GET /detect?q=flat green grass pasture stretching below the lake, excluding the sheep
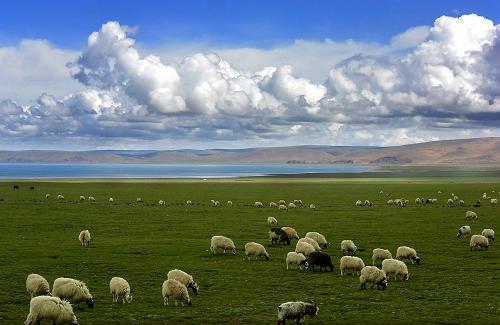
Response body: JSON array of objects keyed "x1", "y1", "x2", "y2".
[{"x1": 0, "y1": 178, "x2": 500, "y2": 324}]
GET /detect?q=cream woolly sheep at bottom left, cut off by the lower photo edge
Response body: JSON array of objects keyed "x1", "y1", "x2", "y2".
[{"x1": 24, "y1": 296, "x2": 78, "y2": 325}]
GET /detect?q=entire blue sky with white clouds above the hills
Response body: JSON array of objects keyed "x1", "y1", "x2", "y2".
[{"x1": 0, "y1": 0, "x2": 500, "y2": 150}]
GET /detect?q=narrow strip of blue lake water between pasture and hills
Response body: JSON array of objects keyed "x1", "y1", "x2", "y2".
[{"x1": 0, "y1": 164, "x2": 374, "y2": 179}]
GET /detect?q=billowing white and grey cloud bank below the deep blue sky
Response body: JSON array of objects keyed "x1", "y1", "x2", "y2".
[{"x1": 0, "y1": 14, "x2": 500, "y2": 148}]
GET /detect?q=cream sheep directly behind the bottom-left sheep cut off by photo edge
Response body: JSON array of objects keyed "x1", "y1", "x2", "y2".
[{"x1": 52, "y1": 278, "x2": 94, "y2": 309}]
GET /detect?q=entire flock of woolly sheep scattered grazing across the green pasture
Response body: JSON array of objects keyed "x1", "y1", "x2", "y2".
[{"x1": 16, "y1": 186, "x2": 496, "y2": 325}]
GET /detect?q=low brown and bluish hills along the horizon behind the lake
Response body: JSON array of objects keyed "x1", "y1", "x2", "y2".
[{"x1": 0, "y1": 138, "x2": 500, "y2": 165}]
